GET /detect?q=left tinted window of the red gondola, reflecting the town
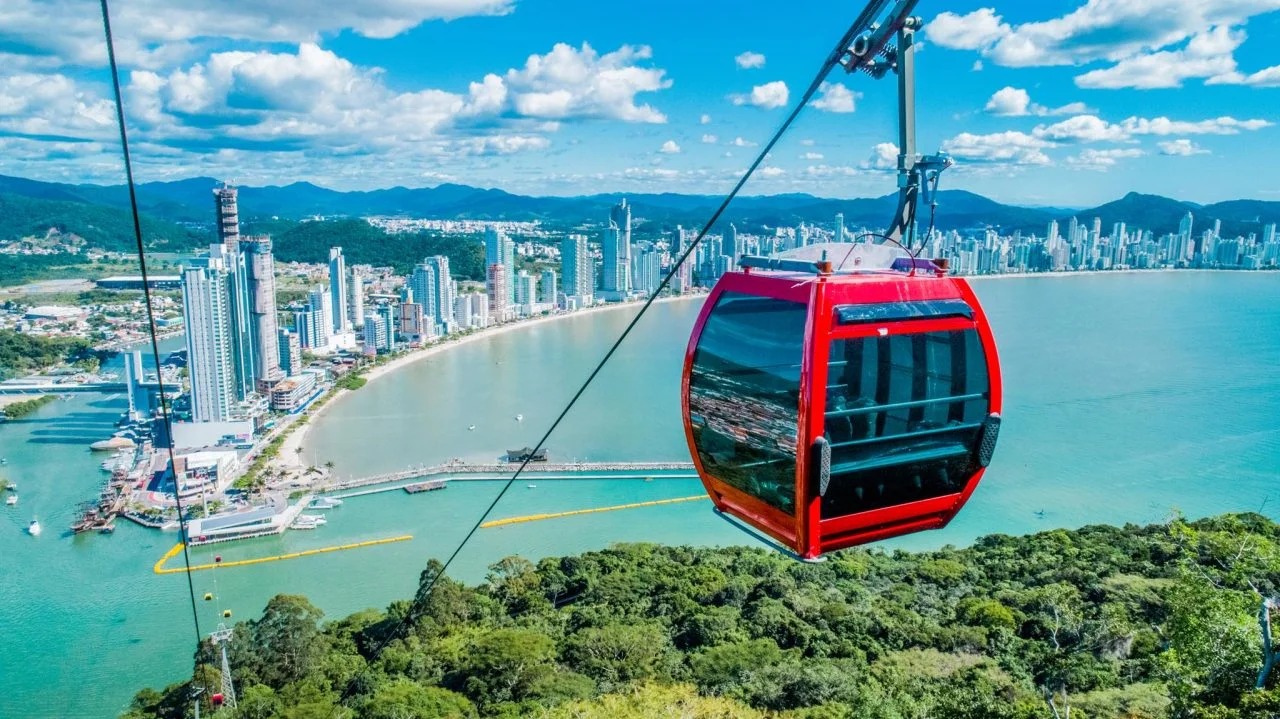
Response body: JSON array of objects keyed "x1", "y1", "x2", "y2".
[{"x1": 689, "y1": 292, "x2": 806, "y2": 513}]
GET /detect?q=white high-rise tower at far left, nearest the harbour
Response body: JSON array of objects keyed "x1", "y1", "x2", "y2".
[{"x1": 182, "y1": 256, "x2": 237, "y2": 422}]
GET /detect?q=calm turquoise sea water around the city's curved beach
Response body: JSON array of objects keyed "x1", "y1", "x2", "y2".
[{"x1": 0, "y1": 273, "x2": 1280, "y2": 718}]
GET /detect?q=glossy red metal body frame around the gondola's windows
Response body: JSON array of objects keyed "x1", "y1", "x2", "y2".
[{"x1": 681, "y1": 266, "x2": 1002, "y2": 558}]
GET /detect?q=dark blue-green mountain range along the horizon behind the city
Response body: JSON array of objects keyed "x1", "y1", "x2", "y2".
[{"x1": 0, "y1": 175, "x2": 1280, "y2": 244}]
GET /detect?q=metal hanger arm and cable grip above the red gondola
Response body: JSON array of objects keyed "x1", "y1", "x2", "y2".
[{"x1": 840, "y1": 0, "x2": 952, "y2": 251}]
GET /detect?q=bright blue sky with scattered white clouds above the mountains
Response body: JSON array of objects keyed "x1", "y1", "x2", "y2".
[{"x1": 0, "y1": 0, "x2": 1280, "y2": 206}]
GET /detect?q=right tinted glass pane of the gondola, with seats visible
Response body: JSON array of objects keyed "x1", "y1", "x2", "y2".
[{"x1": 822, "y1": 330, "x2": 991, "y2": 517}]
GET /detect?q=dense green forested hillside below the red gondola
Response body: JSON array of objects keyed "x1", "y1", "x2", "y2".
[{"x1": 125, "y1": 514, "x2": 1280, "y2": 719}]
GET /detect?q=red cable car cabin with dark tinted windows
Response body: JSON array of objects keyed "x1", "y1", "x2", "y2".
[{"x1": 682, "y1": 244, "x2": 1001, "y2": 558}]
